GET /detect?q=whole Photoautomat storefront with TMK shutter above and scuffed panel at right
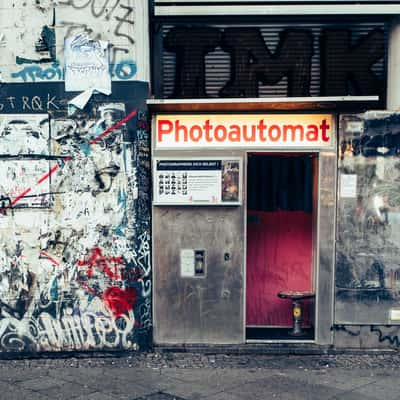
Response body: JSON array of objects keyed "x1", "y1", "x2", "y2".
[{"x1": 148, "y1": 0, "x2": 400, "y2": 348}]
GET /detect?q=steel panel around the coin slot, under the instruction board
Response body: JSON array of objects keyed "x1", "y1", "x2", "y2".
[{"x1": 153, "y1": 207, "x2": 244, "y2": 344}]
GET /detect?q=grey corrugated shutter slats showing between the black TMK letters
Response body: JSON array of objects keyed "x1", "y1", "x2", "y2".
[{"x1": 160, "y1": 23, "x2": 385, "y2": 98}]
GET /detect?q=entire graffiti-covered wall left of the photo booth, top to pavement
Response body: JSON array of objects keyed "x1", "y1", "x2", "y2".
[{"x1": 0, "y1": 0, "x2": 152, "y2": 353}]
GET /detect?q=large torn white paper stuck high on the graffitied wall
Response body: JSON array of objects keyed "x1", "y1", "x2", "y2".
[{"x1": 64, "y1": 33, "x2": 111, "y2": 92}]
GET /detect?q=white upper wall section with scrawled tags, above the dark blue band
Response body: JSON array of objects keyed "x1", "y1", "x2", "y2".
[{"x1": 0, "y1": 0, "x2": 141, "y2": 82}]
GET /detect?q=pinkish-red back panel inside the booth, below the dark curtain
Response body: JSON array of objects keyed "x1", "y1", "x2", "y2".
[{"x1": 246, "y1": 210, "x2": 312, "y2": 326}]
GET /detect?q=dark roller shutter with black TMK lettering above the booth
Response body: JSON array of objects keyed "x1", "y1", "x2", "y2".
[{"x1": 154, "y1": 23, "x2": 386, "y2": 99}]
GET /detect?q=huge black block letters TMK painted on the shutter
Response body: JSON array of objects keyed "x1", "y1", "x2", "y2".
[{"x1": 163, "y1": 26, "x2": 385, "y2": 98}]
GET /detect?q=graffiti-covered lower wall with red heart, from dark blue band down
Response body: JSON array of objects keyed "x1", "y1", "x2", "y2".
[{"x1": 0, "y1": 82, "x2": 151, "y2": 352}]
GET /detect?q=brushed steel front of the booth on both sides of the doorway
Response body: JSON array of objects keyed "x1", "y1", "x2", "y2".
[{"x1": 153, "y1": 114, "x2": 337, "y2": 344}]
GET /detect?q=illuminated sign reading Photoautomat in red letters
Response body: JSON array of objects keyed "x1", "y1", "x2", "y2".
[{"x1": 156, "y1": 114, "x2": 333, "y2": 149}]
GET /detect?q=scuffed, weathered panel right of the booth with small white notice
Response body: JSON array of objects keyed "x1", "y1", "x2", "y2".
[{"x1": 336, "y1": 112, "x2": 400, "y2": 324}]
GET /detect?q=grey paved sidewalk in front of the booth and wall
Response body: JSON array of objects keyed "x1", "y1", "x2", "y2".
[{"x1": 0, "y1": 353, "x2": 400, "y2": 400}]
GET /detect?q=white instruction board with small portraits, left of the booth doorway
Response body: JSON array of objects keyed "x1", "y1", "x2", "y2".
[{"x1": 154, "y1": 158, "x2": 241, "y2": 205}]
